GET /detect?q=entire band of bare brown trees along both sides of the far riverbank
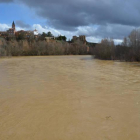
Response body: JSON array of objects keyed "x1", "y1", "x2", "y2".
[{"x1": 0, "y1": 29, "x2": 140, "y2": 62}]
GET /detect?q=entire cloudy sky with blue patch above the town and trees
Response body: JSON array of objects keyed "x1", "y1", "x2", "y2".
[{"x1": 0, "y1": 0, "x2": 140, "y2": 42}]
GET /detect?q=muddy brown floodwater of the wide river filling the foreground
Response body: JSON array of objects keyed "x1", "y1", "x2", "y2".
[{"x1": 0, "y1": 56, "x2": 140, "y2": 140}]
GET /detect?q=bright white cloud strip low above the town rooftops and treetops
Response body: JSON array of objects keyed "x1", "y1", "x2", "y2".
[{"x1": 0, "y1": 24, "x2": 122, "y2": 44}]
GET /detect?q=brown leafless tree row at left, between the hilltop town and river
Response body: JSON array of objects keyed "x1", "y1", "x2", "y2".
[{"x1": 0, "y1": 38, "x2": 87, "y2": 56}]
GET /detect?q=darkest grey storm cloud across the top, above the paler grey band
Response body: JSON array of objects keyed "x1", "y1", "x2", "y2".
[{"x1": 16, "y1": 0, "x2": 140, "y2": 29}]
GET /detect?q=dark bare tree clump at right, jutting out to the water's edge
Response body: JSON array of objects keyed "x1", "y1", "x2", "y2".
[{"x1": 92, "y1": 29, "x2": 140, "y2": 62}]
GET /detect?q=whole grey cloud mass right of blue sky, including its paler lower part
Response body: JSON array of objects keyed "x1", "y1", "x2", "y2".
[{"x1": 0, "y1": 0, "x2": 140, "y2": 38}]
